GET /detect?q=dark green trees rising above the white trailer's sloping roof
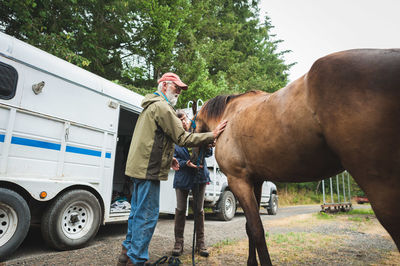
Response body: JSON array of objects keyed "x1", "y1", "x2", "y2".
[{"x1": 0, "y1": 0, "x2": 133, "y2": 79}]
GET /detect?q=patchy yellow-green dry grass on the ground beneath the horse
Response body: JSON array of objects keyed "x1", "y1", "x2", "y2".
[{"x1": 182, "y1": 209, "x2": 400, "y2": 266}]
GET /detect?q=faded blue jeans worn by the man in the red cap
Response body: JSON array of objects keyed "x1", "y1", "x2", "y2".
[{"x1": 122, "y1": 178, "x2": 160, "y2": 264}]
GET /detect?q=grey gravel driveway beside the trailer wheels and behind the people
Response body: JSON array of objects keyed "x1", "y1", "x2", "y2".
[{"x1": 5, "y1": 205, "x2": 393, "y2": 265}]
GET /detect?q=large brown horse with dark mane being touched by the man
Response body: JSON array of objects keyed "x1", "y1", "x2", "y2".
[{"x1": 196, "y1": 49, "x2": 400, "y2": 265}]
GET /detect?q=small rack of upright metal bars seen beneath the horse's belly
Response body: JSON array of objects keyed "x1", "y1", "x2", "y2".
[{"x1": 321, "y1": 171, "x2": 352, "y2": 212}]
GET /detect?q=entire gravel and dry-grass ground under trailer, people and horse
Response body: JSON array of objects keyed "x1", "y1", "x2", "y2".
[{"x1": 0, "y1": 207, "x2": 400, "y2": 265}]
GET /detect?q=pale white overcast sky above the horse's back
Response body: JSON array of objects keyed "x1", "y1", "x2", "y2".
[{"x1": 260, "y1": 0, "x2": 400, "y2": 81}]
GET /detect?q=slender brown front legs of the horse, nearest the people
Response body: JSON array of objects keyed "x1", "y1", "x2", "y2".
[{"x1": 228, "y1": 176, "x2": 272, "y2": 265}]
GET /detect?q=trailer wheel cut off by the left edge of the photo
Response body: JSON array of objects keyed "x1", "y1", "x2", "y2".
[{"x1": 0, "y1": 188, "x2": 31, "y2": 261}]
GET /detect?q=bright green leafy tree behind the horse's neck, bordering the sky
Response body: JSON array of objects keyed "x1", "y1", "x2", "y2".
[{"x1": 173, "y1": 0, "x2": 291, "y2": 106}]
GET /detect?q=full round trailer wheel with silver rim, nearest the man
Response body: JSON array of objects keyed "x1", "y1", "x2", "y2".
[{"x1": 41, "y1": 190, "x2": 101, "y2": 250}]
